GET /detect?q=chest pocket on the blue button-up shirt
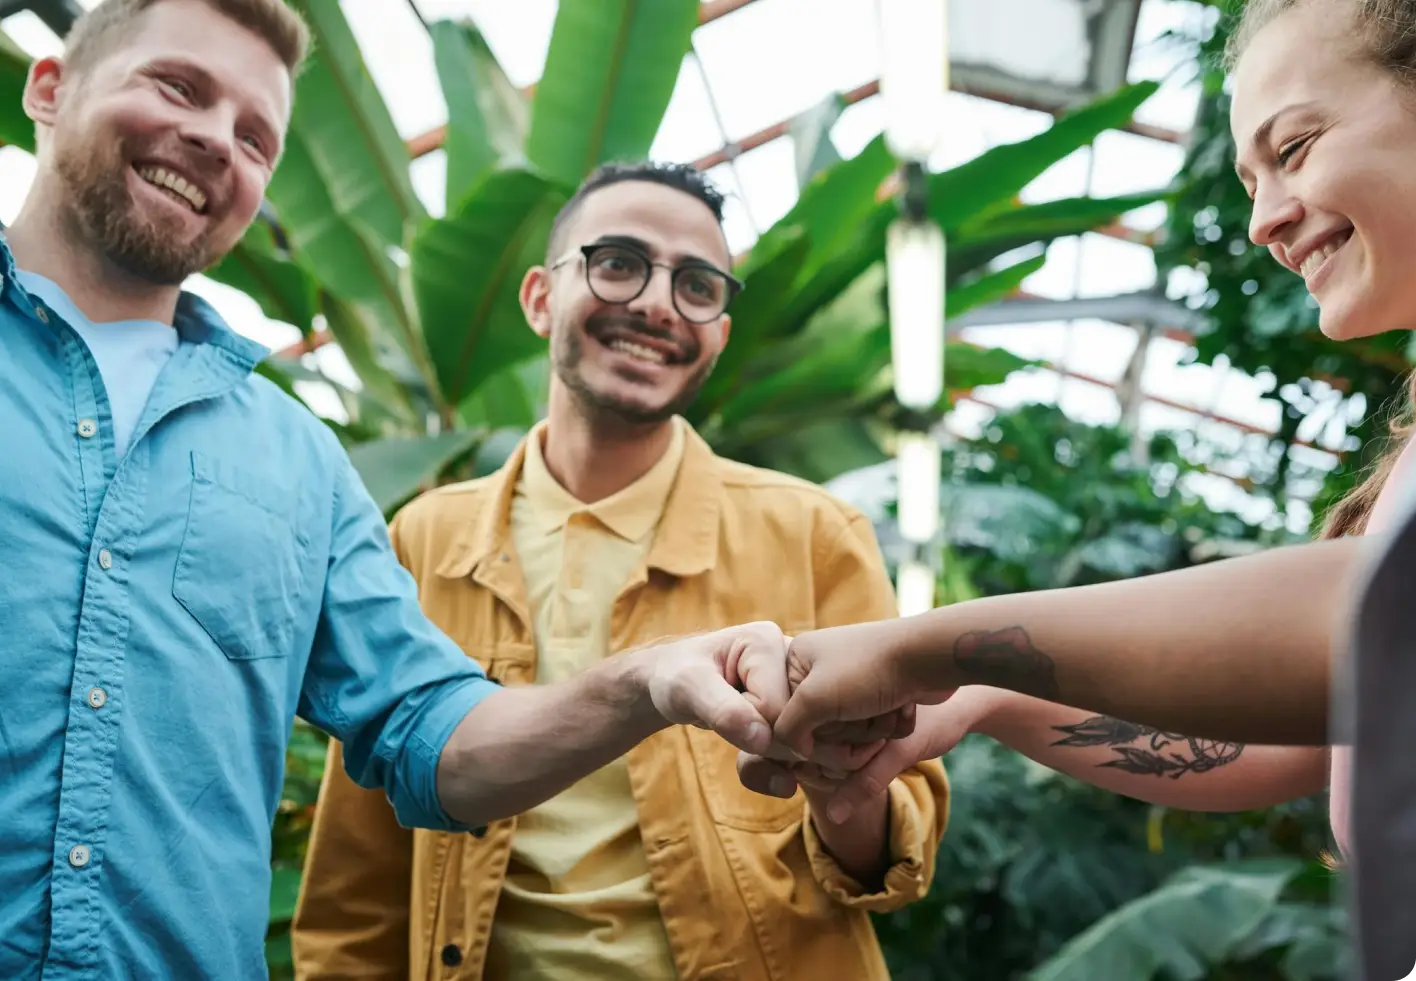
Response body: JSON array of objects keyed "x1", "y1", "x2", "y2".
[{"x1": 173, "y1": 453, "x2": 307, "y2": 661}]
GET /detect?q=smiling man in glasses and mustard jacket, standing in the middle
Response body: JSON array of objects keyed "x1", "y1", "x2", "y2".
[{"x1": 295, "y1": 164, "x2": 947, "y2": 981}]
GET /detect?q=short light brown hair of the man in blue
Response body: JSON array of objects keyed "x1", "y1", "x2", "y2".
[{"x1": 64, "y1": 0, "x2": 310, "y2": 75}]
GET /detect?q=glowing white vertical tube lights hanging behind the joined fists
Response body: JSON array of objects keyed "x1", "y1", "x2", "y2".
[{"x1": 878, "y1": 0, "x2": 949, "y2": 616}]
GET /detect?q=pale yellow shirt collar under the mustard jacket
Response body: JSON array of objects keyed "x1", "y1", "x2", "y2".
[{"x1": 517, "y1": 416, "x2": 684, "y2": 542}]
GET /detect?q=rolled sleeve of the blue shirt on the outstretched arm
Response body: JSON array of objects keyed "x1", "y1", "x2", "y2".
[{"x1": 299, "y1": 454, "x2": 498, "y2": 831}]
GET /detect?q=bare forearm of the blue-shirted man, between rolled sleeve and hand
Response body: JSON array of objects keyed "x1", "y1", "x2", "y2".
[{"x1": 438, "y1": 651, "x2": 667, "y2": 827}]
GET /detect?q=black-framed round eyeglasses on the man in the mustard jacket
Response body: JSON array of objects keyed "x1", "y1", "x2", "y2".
[{"x1": 551, "y1": 242, "x2": 742, "y2": 324}]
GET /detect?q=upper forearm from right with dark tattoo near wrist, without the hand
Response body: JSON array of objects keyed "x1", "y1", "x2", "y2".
[{"x1": 889, "y1": 538, "x2": 1362, "y2": 745}]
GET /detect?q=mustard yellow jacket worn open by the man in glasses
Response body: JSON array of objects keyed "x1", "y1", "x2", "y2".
[{"x1": 293, "y1": 430, "x2": 949, "y2": 981}]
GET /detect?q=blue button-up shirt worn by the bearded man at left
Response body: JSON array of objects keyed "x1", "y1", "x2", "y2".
[{"x1": 0, "y1": 238, "x2": 496, "y2": 981}]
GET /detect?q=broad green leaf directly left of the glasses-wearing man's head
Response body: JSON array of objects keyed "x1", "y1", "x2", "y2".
[{"x1": 411, "y1": 170, "x2": 565, "y2": 405}]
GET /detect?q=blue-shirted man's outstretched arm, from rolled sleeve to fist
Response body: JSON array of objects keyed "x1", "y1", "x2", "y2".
[{"x1": 300, "y1": 450, "x2": 786, "y2": 831}]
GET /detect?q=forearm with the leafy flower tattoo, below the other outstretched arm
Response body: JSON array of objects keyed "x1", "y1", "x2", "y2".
[{"x1": 954, "y1": 688, "x2": 1328, "y2": 811}]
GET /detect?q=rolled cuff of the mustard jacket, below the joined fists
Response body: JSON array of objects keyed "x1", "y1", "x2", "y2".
[{"x1": 801, "y1": 777, "x2": 930, "y2": 913}]
